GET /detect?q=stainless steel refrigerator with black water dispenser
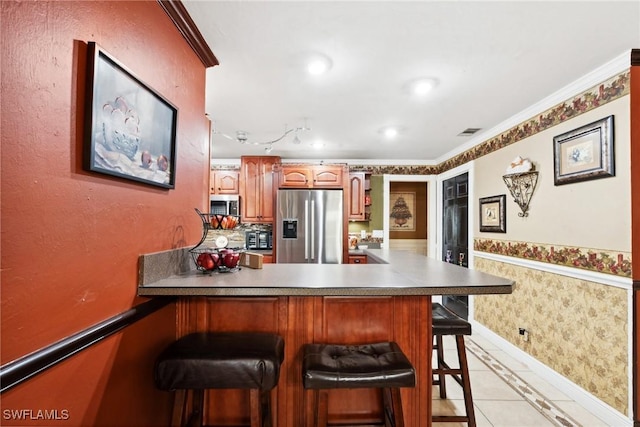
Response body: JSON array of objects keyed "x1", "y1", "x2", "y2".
[{"x1": 274, "y1": 190, "x2": 344, "y2": 264}]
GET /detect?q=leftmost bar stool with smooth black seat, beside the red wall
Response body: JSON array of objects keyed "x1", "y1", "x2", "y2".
[{"x1": 154, "y1": 332, "x2": 284, "y2": 427}]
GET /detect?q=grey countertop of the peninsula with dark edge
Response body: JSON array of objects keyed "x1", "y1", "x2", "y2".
[{"x1": 138, "y1": 249, "x2": 514, "y2": 296}]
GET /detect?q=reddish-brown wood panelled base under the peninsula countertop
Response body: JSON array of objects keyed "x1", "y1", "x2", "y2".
[{"x1": 176, "y1": 296, "x2": 431, "y2": 427}]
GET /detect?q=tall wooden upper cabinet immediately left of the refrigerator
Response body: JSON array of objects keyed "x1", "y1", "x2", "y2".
[{"x1": 240, "y1": 156, "x2": 280, "y2": 223}]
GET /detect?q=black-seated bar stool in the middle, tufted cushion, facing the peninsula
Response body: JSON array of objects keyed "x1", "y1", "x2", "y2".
[{"x1": 302, "y1": 342, "x2": 416, "y2": 427}]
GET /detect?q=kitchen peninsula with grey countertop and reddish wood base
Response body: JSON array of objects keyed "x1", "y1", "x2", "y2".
[{"x1": 138, "y1": 249, "x2": 513, "y2": 427}]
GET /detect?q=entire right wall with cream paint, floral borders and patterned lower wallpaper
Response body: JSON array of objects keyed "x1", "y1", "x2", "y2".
[{"x1": 474, "y1": 71, "x2": 632, "y2": 414}]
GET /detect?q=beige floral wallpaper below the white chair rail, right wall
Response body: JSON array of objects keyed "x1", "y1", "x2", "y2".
[{"x1": 474, "y1": 257, "x2": 631, "y2": 414}]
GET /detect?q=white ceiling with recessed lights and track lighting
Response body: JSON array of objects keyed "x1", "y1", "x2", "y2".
[{"x1": 183, "y1": 0, "x2": 640, "y2": 164}]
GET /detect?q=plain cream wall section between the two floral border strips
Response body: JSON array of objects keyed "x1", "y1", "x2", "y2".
[{"x1": 474, "y1": 95, "x2": 631, "y2": 252}]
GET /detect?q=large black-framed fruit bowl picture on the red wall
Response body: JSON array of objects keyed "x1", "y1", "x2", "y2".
[{"x1": 83, "y1": 42, "x2": 178, "y2": 188}]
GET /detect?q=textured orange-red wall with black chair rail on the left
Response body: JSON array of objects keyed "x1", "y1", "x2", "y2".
[{"x1": 0, "y1": 1, "x2": 209, "y2": 426}]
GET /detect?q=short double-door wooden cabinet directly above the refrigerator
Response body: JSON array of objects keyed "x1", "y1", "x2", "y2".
[{"x1": 276, "y1": 164, "x2": 349, "y2": 188}]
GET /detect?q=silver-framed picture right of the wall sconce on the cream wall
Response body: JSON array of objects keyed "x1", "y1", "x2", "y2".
[{"x1": 553, "y1": 116, "x2": 615, "y2": 185}]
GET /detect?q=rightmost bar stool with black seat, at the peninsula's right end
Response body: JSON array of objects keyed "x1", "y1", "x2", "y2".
[{"x1": 431, "y1": 303, "x2": 476, "y2": 427}]
